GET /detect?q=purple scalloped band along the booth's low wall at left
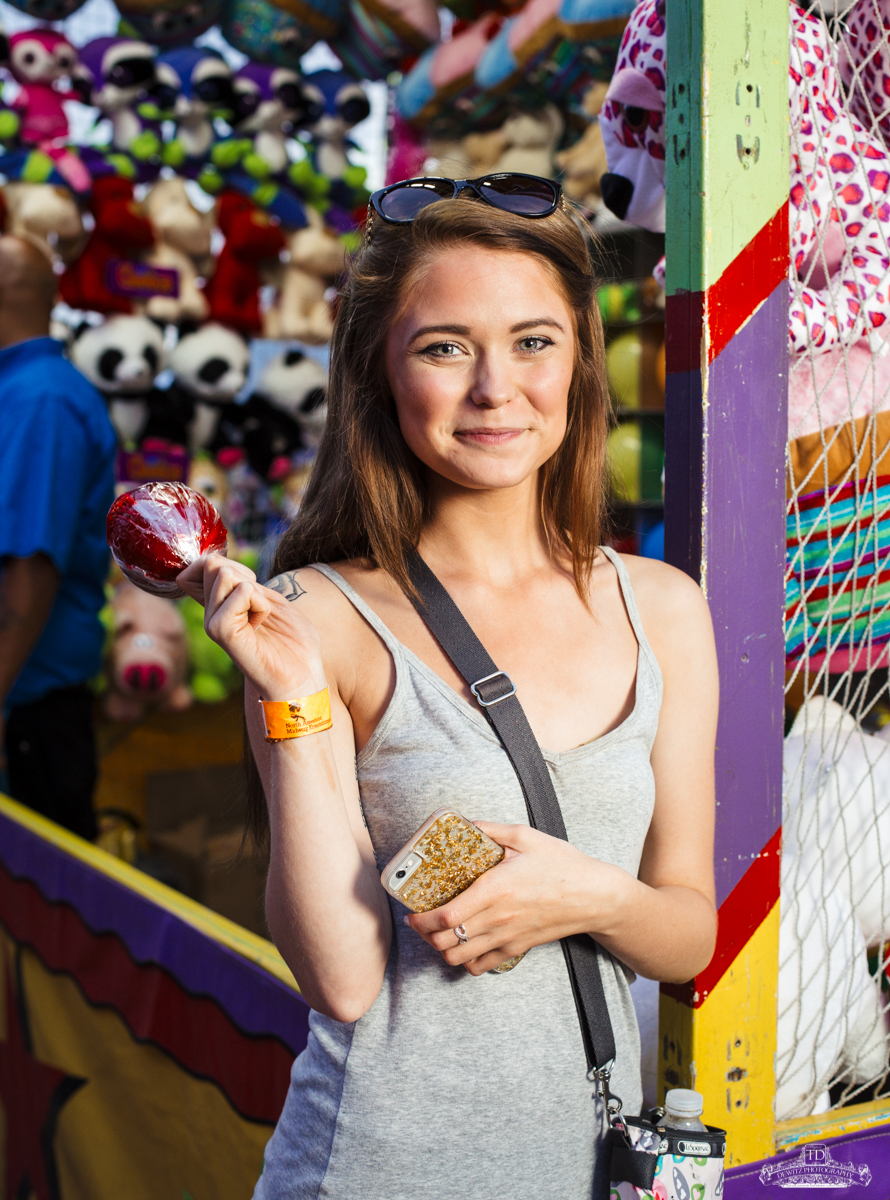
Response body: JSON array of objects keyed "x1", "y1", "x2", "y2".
[{"x1": 0, "y1": 815, "x2": 308, "y2": 1055}]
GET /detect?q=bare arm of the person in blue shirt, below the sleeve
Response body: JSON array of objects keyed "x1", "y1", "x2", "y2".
[{"x1": 0, "y1": 554, "x2": 59, "y2": 769}]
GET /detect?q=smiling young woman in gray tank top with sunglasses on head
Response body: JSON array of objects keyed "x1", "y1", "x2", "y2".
[{"x1": 181, "y1": 176, "x2": 717, "y2": 1200}]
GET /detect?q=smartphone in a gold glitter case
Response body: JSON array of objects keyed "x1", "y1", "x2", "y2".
[{"x1": 380, "y1": 809, "x2": 524, "y2": 974}]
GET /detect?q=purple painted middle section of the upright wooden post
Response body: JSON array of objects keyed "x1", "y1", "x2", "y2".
[{"x1": 665, "y1": 282, "x2": 788, "y2": 904}]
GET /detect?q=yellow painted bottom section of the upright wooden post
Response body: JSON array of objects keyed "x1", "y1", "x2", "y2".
[{"x1": 659, "y1": 905, "x2": 778, "y2": 1165}]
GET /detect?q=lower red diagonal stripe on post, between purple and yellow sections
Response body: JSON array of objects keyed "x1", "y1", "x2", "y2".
[{"x1": 661, "y1": 826, "x2": 782, "y2": 1008}]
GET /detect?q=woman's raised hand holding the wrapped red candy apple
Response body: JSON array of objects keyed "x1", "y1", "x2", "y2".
[{"x1": 176, "y1": 554, "x2": 325, "y2": 700}]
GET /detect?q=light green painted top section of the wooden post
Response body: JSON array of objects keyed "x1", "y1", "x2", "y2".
[{"x1": 666, "y1": 0, "x2": 789, "y2": 295}]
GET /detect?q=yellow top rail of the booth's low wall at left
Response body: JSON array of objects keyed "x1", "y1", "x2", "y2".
[{"x1": 0, "y1": 794, "x2": 300, "y2": 991}]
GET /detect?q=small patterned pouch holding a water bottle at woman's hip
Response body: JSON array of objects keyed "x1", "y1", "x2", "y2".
[{"x1": 609, "y1": 1117, "x2": 726, "y2": 1200}]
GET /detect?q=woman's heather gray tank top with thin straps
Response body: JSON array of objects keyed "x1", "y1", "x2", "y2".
[{"x1": 254, "y1": 550, "x2": 662, "y2": 1200}]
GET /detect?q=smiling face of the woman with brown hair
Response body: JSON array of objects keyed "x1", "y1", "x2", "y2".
[{"x1": 386, "y1": 246, "x2": 575, "y2": 490}]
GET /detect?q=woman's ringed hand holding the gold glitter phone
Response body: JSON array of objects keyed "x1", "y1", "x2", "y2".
[{"x1": 404, "y1": 821, "x2": 641, "y2": 976}]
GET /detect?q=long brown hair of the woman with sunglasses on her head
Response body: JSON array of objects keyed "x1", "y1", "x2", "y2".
[{"x1": 246, "y1": 198, "x2": 609, "y2": 846}]
